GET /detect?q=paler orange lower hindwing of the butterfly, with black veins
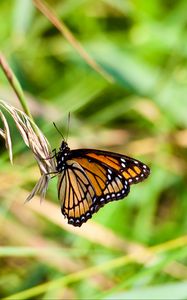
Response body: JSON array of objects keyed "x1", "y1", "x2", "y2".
[{"x1": 58, "y1": 160, "x2": 96, "y2": 226}]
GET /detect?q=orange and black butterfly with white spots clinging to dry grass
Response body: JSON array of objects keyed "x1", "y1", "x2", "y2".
[{"x1": 55, "y1": 140, "x2": 150, "y2": 227}]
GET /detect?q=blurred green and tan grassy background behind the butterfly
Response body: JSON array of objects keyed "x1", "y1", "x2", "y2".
[{"x1": 0, "y1": 0, "x2": 187, "y2": 299}]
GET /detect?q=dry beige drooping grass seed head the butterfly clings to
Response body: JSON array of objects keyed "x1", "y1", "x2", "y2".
[{"x1": 0, "y1": 100, "x2": 56, "y2": 201}]
